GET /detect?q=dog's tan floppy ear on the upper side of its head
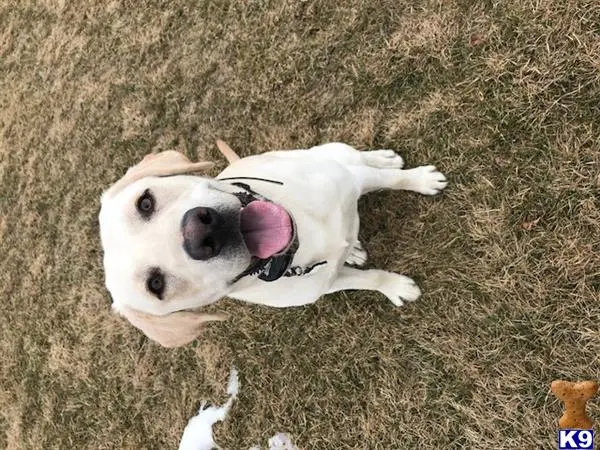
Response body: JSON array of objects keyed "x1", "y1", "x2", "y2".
[{"x1": 103, "y1": 150, "x2": 214, "y2": 197}]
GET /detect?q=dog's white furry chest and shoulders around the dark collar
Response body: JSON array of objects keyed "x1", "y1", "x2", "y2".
[{"x1": 219, "y1": 156, "x2": 359, "y2": 307}]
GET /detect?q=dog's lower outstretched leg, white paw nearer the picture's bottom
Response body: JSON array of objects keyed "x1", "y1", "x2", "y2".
[{"x1": 327, "y1": 266, "x2": 421, "y2": 306}]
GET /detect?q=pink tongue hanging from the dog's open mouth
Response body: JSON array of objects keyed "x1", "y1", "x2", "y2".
[{"x1": 241, "y1": 200, "x2": 292, "y2": 259}]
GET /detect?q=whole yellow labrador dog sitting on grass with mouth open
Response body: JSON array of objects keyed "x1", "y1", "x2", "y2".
[{"x1": 99, "y1": 143, "x2": 447, "y2": 347}]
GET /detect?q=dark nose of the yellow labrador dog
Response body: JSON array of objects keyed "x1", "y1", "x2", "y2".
[{"x1": 181, "y1": 207, "x2": 223, "y2": 261}]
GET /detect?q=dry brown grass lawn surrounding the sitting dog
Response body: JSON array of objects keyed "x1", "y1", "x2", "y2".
[{"x1": 0, "y1": 0, "x2": 600, "y2": 450}]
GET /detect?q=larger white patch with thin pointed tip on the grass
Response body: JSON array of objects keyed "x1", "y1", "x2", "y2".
[{"x1": 179, "y1": 369, "x2": 239, "y2": 450}]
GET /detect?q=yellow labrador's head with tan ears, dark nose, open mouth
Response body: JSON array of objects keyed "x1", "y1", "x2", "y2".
[{"x1": 99, "y1": 151, "x2": 289, "y2": 347}]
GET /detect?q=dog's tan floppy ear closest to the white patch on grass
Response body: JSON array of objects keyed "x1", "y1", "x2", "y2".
[{"x1": 116, "y1": 306, "x2": 226, "y2": 348}]
